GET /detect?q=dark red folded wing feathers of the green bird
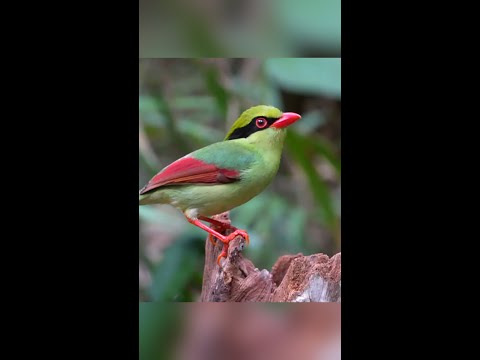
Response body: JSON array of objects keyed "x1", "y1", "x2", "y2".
[{"x1": 140, "y1": 157, "x2": 239, "y2": 195}]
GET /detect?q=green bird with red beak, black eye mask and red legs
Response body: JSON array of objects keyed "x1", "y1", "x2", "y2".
[{"x1": 139, "y1": 105, "x2": 301, "y2": 266}]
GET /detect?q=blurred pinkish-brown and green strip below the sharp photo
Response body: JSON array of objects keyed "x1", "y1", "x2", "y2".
[{"x1": 139, "y1": 303, "x2": 341, "y2": 360}]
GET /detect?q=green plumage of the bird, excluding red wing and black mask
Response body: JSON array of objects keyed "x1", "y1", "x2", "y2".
[{"x1": 140, "y1": 105, "x2": 296, "y2": 218}]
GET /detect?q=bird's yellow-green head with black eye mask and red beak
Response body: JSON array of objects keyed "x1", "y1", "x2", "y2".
[{"x1": 225, "y1": 105, "x2": 301, "y2": 144}]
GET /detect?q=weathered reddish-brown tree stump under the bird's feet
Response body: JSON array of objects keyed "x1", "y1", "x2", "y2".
[{"x1": 201, "y1": 212, "x2": 341, "y2": 302}]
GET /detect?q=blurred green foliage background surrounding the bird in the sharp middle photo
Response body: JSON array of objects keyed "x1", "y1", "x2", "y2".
[{"x1": 139, "y1": 58, "x2": 341, "y2": 301}]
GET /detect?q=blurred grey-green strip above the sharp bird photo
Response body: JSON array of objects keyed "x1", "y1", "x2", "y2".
[{"x1": 139, "y1": 0, "x2": 341, "y2": 58}]
